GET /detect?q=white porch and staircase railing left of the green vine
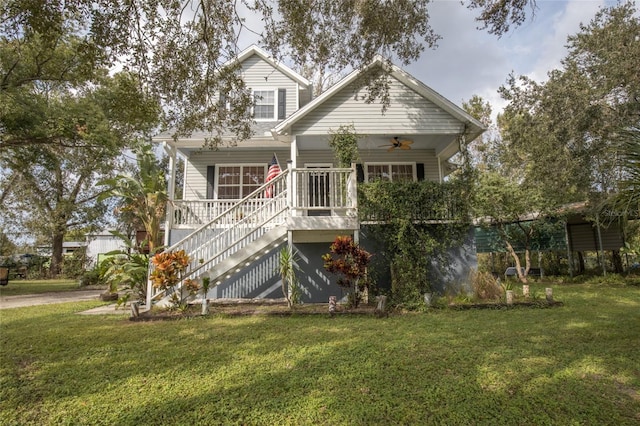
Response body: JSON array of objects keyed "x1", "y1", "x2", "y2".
[{"x1": 147, "y1": 166, "x2": 357, "y2": 306}]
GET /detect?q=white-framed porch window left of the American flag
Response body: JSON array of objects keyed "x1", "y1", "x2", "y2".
[{"x1": 217, "y1": 165, "x2": 267, "y2": 200}]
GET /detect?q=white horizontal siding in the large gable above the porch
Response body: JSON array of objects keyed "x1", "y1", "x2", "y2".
[{"x1": 292, "y1": 78, "x2": 461, "y2": 135}]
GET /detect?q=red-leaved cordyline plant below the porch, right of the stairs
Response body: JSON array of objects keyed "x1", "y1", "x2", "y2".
[{"x1": 322, "y1": 236, "x2": 371, "y2": 307}]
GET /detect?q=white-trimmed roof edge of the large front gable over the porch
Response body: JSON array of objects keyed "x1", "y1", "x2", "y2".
[{"x1": 271, "y1": 56, "x2": 486, "y2": 140}]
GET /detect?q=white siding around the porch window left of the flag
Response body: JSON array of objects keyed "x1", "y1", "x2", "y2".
[{"x1": 184, "y1": 148, "x2": 289, "y2": 200}]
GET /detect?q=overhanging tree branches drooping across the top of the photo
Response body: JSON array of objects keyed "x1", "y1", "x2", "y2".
[{"x1": 0, "y1": 0, "x2": 535, "y2": 145}]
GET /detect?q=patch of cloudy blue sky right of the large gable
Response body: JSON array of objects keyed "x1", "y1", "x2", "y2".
[{"x1": 405, "y1": 0, "x2": 616, "y2": 113}]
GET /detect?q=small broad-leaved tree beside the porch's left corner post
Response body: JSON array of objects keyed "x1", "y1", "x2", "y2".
[{"x1": 100, "y1": 145, "x2": 169, "y2": 254}]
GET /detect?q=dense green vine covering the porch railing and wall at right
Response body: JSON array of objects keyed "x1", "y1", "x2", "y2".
[{"x1": 358, "y1": 180, "x2": 470, "y2": 307}]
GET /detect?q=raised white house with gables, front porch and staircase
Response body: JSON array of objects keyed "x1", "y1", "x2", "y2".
[{"x1": 148, "y1": 46, "x2": 484, "y2": 303}]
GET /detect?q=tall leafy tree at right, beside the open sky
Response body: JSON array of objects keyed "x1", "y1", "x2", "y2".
[{"x1": 501, "y1": 3, "x2": 640, "y2": 206}]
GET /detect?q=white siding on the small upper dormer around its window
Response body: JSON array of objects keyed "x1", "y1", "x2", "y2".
[{"x1": 242, "y1": 55, "x2": 298, "y2": 117}]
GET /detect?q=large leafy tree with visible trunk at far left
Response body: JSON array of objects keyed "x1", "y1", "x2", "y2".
[{"x1": 0, "y1": 65, "x2": 158, "y2": 276}]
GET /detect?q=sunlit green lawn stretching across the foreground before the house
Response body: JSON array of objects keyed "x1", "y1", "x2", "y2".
[{"x1": 0, "y1": 284, "x2": 640, "y2": 425}]
